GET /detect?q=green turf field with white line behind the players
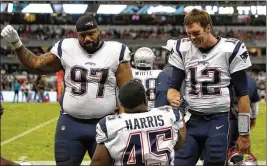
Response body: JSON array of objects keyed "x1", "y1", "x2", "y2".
[{"x1": 1, "y1": 103, "x2": 266, "y2": 161}]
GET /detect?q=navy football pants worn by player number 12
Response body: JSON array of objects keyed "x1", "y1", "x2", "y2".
[{"x1": 174, "y1": 113, "x2": 230, "y2": 166}]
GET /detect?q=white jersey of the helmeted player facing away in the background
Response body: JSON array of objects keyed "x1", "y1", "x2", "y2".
[{"x1": 132, "y1": 68, "x2": 161, "y2": 109}]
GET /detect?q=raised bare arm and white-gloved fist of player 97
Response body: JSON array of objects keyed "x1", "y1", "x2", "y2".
[{"x1": 1, "y1": 25, "x2": 62, "y2": 75}]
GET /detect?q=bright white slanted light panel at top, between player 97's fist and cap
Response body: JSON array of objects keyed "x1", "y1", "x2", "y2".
[{"x1": 21, "y1": 3, "x2": 53, "y2": 13}]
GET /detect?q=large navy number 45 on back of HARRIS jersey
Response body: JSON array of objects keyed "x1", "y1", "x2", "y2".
[{"x1": 121, "y1": 127, "x2": 174, "y2": 166}]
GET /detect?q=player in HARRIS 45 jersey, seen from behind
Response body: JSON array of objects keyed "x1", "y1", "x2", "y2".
[{"x1": 91, "y1": 80, "x2": 186, "y2": 166}]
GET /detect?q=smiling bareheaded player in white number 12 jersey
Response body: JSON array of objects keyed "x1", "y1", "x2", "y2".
[{"x1": 167, "y1": 9, "x2": 251, "y2": 166}]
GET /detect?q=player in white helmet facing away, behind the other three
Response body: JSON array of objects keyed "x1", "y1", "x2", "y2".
[{"x1": 132, "y1": 47, "x2": 161, "y2": 109}]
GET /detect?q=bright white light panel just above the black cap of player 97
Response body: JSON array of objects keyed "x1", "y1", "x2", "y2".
[{"x1": 63, "y1": 4, "x2": 88, "y2": 14}]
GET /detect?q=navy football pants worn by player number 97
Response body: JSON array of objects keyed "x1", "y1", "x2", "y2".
[{"x1": 54, "y1": 114, "x2": 100, "y2": 166}]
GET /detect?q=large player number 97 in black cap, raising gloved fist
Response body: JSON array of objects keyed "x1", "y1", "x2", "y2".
[{"x1": 1, "y1": 15, "x2": 132, "y2": 165}]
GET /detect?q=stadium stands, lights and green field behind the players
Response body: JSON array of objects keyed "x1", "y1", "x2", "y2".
[{"x1": 0, "y1": 1, "x2": 266, "y2": 165}]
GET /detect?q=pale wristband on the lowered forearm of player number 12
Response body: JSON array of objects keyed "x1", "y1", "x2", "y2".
[{"x1": 238, "y1": 113, "x2": 250, "y2": 135}]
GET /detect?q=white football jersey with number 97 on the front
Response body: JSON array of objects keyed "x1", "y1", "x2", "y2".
[{"x1": 50, "y1": 38, "x2": 130, "y2": 119}]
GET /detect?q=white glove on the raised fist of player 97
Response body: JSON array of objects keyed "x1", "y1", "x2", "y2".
[{"x1": 1, "y1": 25, "x2": 22, "y2": 48}]
